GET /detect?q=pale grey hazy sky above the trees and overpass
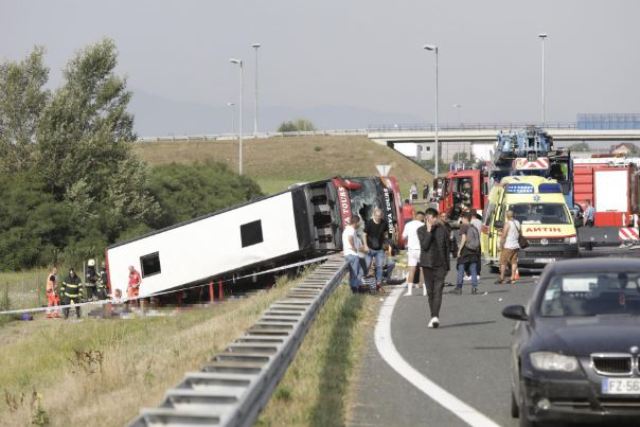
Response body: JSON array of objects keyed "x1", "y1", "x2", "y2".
[{"x1": 0, "y1": 0, "x2": 640, "y2": 130}]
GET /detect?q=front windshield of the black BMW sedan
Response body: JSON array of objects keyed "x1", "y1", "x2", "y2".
[{"x1": 540, "y1": 272, "x2": 640, "y2": 317}]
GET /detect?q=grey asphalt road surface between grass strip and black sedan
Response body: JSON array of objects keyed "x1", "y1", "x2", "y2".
[{"x1": 350, "y1": 262, "x2": 537, "y2": 426}]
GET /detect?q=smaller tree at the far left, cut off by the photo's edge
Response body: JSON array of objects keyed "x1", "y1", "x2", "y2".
[{"x1": 0, "y1": 47, "x2": 50, "y2": 173}]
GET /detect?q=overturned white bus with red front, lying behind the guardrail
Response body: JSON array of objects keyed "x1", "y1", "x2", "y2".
[{"x1": 105, "y1": 177, "x2": 402, "y2": 297}]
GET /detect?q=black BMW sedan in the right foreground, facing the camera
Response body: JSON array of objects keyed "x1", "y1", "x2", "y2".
[{"x1": 502, "y1": 258, "x2": 640, "y2": 426}]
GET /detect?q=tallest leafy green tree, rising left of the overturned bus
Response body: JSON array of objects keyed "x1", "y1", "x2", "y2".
[{"x1": 37, "y1": 39, "x2": 158, "y2": 241}]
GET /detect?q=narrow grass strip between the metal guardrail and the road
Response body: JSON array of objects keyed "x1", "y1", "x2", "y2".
[{"x1": 257, "y1": 285, "x2": 379, "y2": 427}]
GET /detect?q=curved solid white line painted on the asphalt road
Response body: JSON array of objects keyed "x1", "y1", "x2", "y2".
[{"x1": 375, "y1": 287, "x2": 499, "y2": 427}]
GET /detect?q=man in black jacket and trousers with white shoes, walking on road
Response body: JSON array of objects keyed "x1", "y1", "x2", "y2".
[{"x1": 418, "y1": 208, "x2": 450, "y2": 328}]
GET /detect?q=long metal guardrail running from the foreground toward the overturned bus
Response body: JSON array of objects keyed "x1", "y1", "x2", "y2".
[{"x1": 129, "y1": 256, "x2": 347, "y2": 427}]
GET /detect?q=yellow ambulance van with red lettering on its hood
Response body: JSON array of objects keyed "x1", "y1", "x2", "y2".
[{"x1": 481, "y1": 176, "x2": 578, "y2": 269}]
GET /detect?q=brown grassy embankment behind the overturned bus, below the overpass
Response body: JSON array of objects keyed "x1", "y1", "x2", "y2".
[{"x1": 135, "y1": 136, "x2": 432, "y2": 195}]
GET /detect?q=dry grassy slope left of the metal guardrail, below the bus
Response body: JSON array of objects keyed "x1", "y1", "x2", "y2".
[{"x1": 0, "y1": 279, "x2": 302, "y2": 426}]
